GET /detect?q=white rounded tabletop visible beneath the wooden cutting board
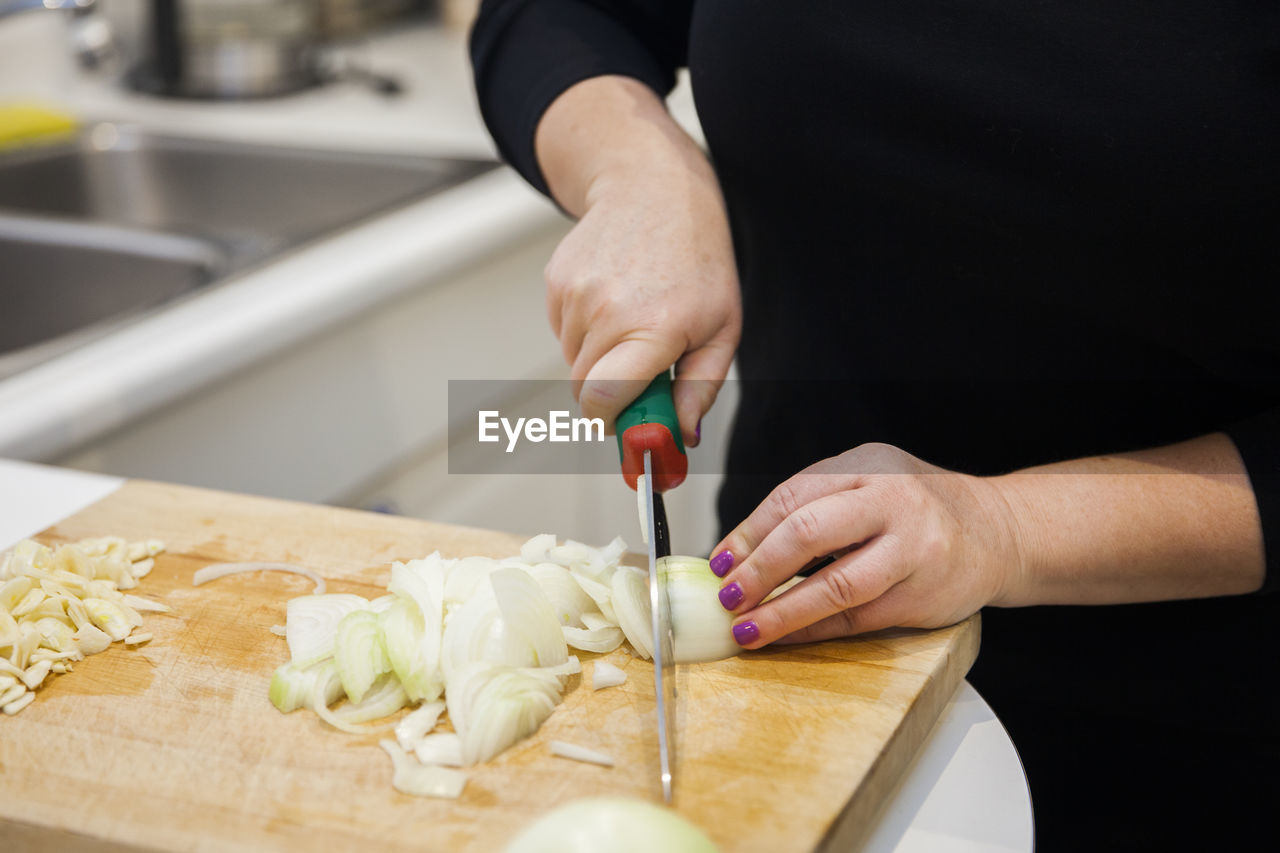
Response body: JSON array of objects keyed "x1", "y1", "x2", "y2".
[{"x1": 0, "y1": 459, "x2": 1032, "y2": 853}]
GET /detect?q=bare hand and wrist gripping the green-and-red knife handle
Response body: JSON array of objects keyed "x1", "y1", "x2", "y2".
[{"x1": 538, "y1": 77, "x2": 742, "y2": 446}]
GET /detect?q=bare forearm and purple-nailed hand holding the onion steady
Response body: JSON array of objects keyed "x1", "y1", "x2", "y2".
[{"x1": 713, "y1": 433, "x2": 1265, "y2": 648}]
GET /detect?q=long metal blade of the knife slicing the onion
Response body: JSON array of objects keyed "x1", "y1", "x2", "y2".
[{"x1": 644, "y1": 450, "x2": 676, "y2": 803}]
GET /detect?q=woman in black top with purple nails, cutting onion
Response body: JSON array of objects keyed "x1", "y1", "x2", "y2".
[{"x1": 472, "y1": 0, "x2": 1280, "y2": 850}]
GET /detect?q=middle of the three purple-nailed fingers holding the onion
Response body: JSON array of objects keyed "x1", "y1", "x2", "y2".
[{"x1": 721, "y1": 489, "x2": 884, "y2": 620}]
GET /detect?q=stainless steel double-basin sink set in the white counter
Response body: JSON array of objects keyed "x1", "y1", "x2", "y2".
[{"x1": 0, "y1": 124, "x2": 495, "y2": 378}]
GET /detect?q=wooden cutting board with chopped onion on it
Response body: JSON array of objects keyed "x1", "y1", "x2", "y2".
[{"x1": 0, "y1": 482, "x2": 979, "y2": 853}]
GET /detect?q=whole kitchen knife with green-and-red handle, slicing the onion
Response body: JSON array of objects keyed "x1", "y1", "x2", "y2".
[{"x1": 617, "y1": 373, "x2": 689, "y2": 803}]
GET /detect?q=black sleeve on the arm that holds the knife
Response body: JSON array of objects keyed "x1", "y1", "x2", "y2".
[{"x1": 471, "y1": 0, "x2": 692, "y2": 195}]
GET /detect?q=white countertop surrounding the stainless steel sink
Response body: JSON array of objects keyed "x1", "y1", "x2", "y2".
[{"x1": 0, "y1": 13, "x2": 563, "y2": 460}]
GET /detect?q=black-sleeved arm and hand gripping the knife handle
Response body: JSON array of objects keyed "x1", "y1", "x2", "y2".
[{"x1": 471, "y1": 0, "x2": 741, "y2": 446}]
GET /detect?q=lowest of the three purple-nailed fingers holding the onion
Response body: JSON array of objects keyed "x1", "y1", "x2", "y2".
[{"x1": 733, "y1": 543, "x2": 906, "y2": 648}]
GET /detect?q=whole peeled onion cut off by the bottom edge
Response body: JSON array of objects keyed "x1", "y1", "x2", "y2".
[{"x1": 504, "y1": 797, "x2": 716, "y2": 853}]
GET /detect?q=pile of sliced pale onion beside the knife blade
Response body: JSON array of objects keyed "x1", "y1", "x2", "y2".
[{"x1": 259, "y1": 534, "x2": 737, "y2": 795}]
